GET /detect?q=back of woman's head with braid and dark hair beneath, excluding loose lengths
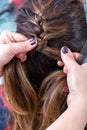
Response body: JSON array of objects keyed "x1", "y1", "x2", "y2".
[{"x1": 16, "y1": 0, "x2": 87, "y2": 88}]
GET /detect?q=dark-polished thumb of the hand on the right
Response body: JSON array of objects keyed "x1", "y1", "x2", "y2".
[{"x1": 61, "y1": 46, "x2": 79, "y2": 70}]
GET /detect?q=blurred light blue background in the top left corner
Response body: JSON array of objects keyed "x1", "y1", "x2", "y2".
[{"x1": 0, "y1": 0, "x2": 23, "y2": 33}]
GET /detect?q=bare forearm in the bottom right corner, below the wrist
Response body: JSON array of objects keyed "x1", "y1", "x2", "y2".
[{"x1": 46, "y1": 99, "x2": 87, "y2": 130}]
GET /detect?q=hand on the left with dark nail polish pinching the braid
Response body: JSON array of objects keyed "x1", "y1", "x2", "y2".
[{"x1": 0, "y1": 31, "x2": 36, "y2": 76}]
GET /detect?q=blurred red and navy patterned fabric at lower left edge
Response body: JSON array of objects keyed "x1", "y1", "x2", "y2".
[{"x1": 0, "y1": 86, "x2": 12, "y2": 130}]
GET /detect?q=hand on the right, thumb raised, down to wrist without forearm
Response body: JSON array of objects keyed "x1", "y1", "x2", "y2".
[{"x1": 58, "y1": 47, "x2": 87, "y2": 105}]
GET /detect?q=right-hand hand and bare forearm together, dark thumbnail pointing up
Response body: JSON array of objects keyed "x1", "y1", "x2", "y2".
[{"x1": 46, "y1": 47, "x2": 87, "y2": 130}]
